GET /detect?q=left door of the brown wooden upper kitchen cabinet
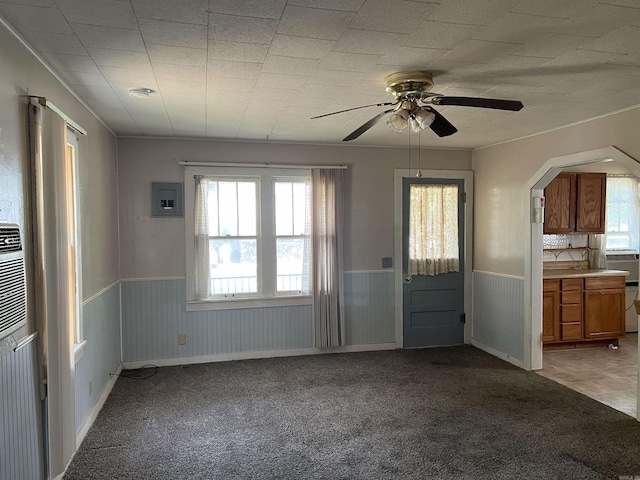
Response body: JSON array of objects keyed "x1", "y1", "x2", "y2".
[{"x1": 544, "y1": 173, "x2": 576, "y2": 233}]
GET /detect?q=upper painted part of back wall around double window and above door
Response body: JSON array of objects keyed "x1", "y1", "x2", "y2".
[{"x1": 118, "y1": 138, "x2": 471, "y2": 278}]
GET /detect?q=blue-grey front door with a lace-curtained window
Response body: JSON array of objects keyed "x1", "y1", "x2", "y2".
[{"x1": 402, "y1": 178, "x2": 464, "y2": 348}]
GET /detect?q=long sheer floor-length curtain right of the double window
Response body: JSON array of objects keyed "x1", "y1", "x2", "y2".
[{"x1": 311, "y1": 169, "x2": 345, "y2": 348}]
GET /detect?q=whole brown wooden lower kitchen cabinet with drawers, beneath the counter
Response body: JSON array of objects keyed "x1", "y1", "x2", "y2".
[{"x1": 542, "y1": 276, "x2": 625, "y2": 348}]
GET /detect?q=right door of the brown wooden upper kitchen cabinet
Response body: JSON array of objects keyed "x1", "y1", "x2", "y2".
[{"x1": 576, "y1": 173, "x2": 607, "y2": 233}]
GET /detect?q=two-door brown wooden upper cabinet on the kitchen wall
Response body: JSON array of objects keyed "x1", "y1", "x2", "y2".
[{"x1": 544, "y1": 173, "x2": 607, "y2": 233}]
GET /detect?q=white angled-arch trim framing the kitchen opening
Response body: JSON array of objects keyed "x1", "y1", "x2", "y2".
[{"x1": 524, "y1": 146, "x2": 640, "y2": 417}]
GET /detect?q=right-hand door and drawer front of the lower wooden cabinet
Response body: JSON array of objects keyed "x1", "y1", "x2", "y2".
[{"x1": 584, "y1": 277, "x2": 625, "y2": 340}]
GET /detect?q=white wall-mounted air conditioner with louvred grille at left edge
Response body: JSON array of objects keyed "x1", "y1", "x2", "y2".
[{"x1": 0, "y1": 223, "x2": 27, "y2": 339}]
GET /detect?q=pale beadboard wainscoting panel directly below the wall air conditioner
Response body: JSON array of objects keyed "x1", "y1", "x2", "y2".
[{"x1": 0, "y1": 341, "x2": 44, "y2": 479}]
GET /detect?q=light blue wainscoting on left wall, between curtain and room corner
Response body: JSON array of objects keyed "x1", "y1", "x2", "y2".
[{"x1": 75, "y1": 282, "x2": 120, "y2": 432}]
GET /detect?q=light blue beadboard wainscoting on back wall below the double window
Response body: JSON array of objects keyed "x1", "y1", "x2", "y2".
[{"x1": 122, "y1": 271, "x2": 395, "y2": 362}]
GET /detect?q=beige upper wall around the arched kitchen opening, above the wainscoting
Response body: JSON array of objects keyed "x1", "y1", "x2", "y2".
[{"x1": 473, "y1": 108, "x2": 640, "y2": 276}]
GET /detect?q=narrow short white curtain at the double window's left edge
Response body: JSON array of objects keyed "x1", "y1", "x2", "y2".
[{"x1": 194, "y1": 175, "x2": 211, "y2": 300}]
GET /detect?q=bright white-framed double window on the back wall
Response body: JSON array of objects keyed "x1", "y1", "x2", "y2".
[{"x1": 185, "y1": 167, "x2": 311, "y2": 306}]
